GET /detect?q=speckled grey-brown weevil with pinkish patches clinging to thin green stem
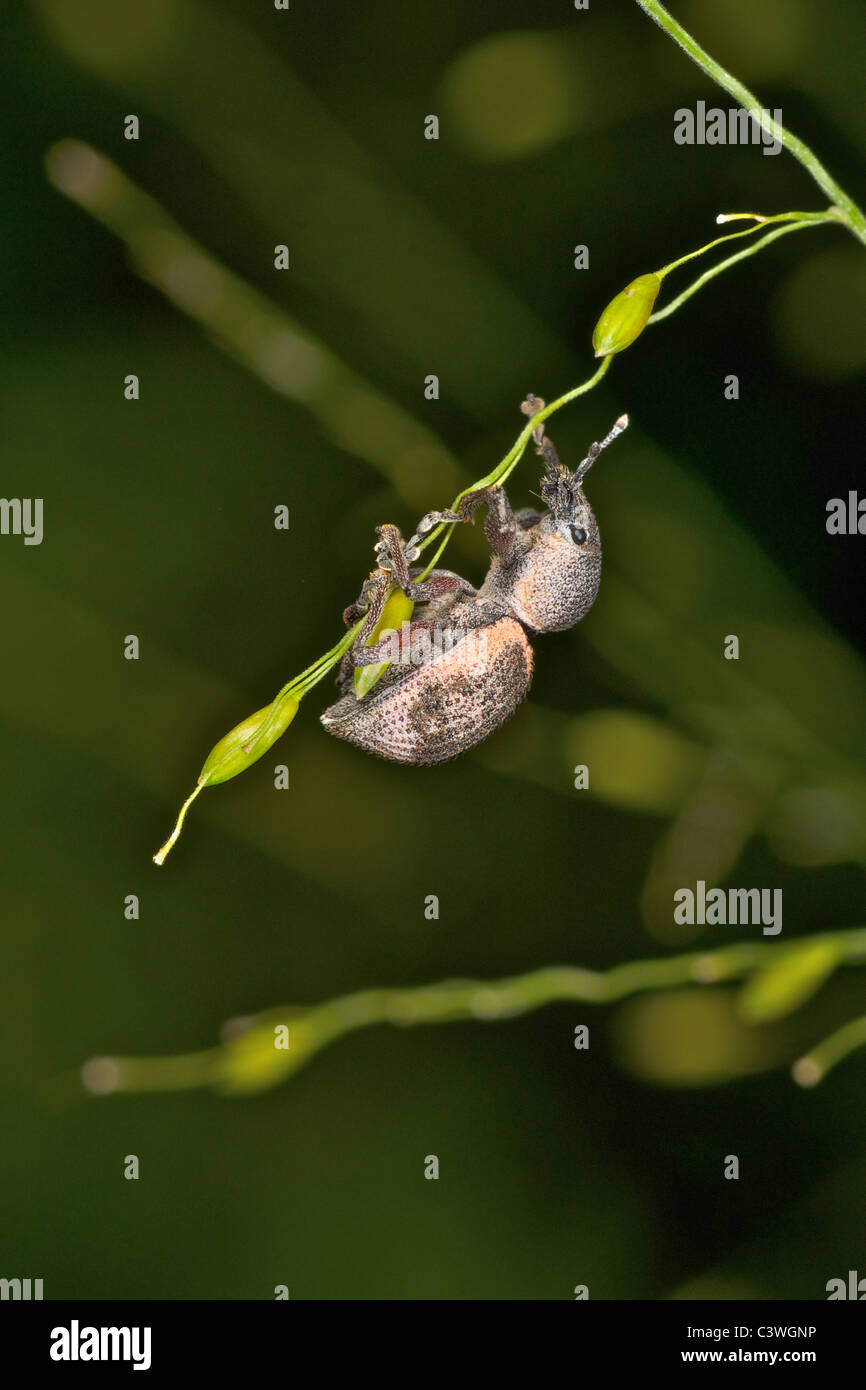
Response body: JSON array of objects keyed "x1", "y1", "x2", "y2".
[{"x1": 320, "y1": 396, "x2": 628, "y2": 766}]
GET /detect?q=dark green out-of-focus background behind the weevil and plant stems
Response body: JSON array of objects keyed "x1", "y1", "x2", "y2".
[{"x1": 0, "y1": 0, "x2": 866, "y2": 1300}]
